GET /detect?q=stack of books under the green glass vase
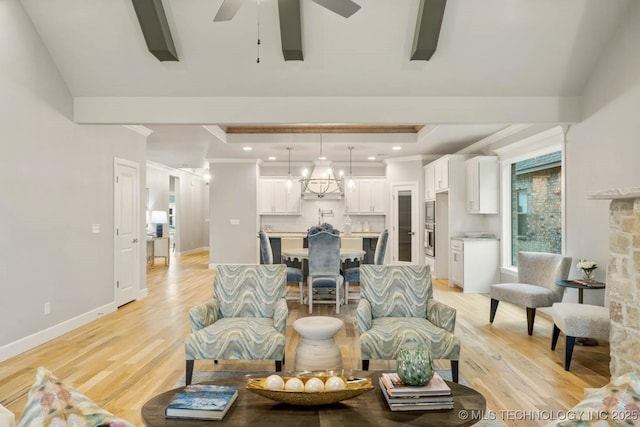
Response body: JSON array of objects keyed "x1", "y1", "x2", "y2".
[{"x1": 380, "y1": 372, "x2": 453, "y2": 411}]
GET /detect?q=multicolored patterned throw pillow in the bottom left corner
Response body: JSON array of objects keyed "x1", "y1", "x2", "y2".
[{"x1": 17, "y1": 367, "x2": 135, "y2": 427}]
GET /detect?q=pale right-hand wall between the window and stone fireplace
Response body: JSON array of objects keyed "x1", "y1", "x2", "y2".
[{"x1": 566, "y1": 2, "x2": 640, "y2": 302}]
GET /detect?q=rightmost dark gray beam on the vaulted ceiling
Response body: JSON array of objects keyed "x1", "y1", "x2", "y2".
[{"x1": 411, "y1": 0, "x2": 447, "y2": 61}]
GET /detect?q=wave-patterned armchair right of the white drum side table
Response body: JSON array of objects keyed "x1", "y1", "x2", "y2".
[{"x1": 357, "y1": 264, "x2": 460, "y2": 382}]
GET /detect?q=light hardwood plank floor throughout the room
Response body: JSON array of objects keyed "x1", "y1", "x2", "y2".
[{"x1": 0, "y1": 252, "x2": 610, "y2": 426}]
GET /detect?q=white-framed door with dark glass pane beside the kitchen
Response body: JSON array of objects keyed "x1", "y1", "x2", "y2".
[{"x1": 391, "y1": 184, "x2": 420, "y2": 264}]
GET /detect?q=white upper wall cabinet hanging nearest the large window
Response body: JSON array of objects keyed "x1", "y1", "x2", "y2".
[{"x1": 465, "y1": 156, "x2": 499, "y2": 214}]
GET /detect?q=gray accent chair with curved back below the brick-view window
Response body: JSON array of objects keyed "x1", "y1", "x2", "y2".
[{"x1": 489, "y1": 252, "x2": 571, "y2": 335}]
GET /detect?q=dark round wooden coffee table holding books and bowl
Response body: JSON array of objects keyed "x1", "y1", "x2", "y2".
[{"x1": 142, "y1": 371, "x2": 486, "y2": 427}]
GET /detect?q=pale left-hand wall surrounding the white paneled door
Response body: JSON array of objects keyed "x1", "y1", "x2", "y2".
[{"x1": 0, "y1": 1, "x2": 146, "y2": 360}]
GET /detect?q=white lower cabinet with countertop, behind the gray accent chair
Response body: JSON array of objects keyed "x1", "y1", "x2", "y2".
[{"x1": 449, "y1": 238, "x2": 500, "y2": 293}]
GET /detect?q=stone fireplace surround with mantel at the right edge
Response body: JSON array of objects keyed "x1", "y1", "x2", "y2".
[{"x1": 589, "y1": 187, "x2": 640, "y2": 378}]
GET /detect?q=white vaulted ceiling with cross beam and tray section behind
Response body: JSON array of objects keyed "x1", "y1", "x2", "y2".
[{"x1": 22, "y1": 0, "x2": 630, "y2": 167}]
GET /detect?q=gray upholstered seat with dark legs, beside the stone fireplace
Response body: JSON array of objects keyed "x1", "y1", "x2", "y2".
[{"x1": 551, "y1": 302, "x2": 611, "y2": 371}]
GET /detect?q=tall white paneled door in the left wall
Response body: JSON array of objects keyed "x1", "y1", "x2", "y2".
[{"x1": 114, "y1": 159, "x2": 140, "y2": 307}]
